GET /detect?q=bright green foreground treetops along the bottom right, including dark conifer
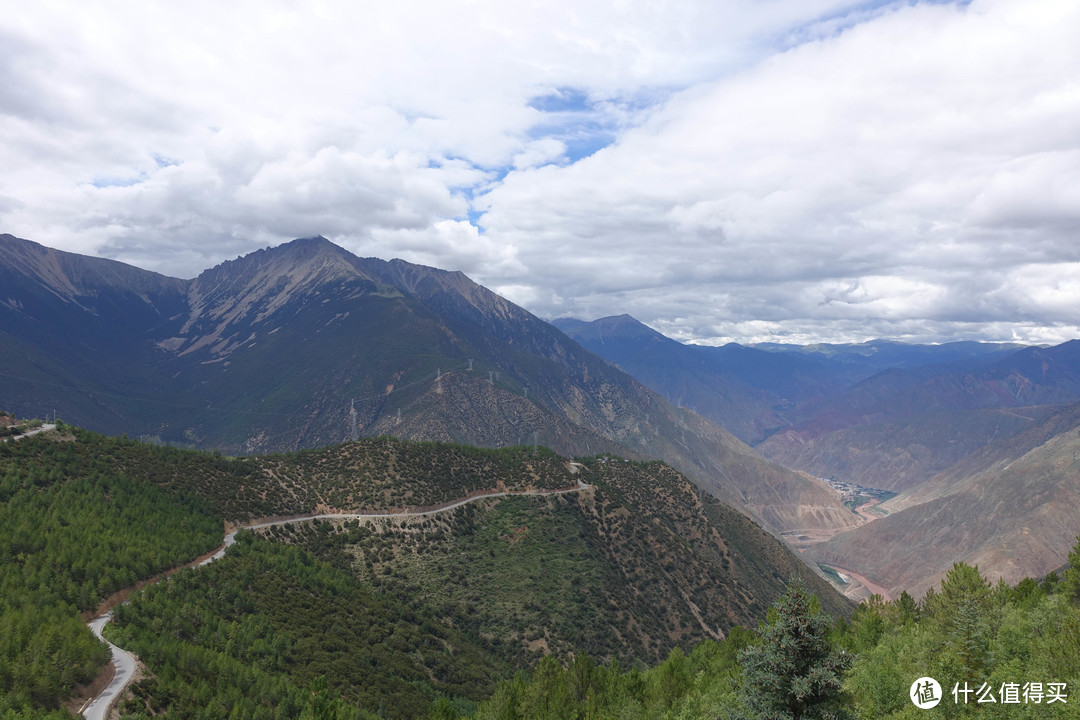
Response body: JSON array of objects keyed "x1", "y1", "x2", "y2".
[{"x1": 460, "y1": 557, "x2": 1080, "y2": 720}]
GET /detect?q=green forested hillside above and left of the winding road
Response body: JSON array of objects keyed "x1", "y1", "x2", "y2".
[{"x1": 0, "y1": 424, "x2": 575, "y2": 717}]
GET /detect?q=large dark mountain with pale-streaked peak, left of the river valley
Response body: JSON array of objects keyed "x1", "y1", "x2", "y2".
[{"x1": 0, "y1": 235, "x2": 858, "y2": 539}]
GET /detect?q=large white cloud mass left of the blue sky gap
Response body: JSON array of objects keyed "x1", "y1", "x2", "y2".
[{"x1": 0, "y1": 0, "x2": 850, "y2": 274}]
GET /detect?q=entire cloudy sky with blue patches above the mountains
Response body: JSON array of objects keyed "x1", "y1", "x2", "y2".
[{"x1": 0, "y1": 0, "x2": 1080, "y2": 344}]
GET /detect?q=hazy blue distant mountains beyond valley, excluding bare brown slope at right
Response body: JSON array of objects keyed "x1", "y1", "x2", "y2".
[{"x1": 554, "y1": 315, "x2": 1080, "y2": 498}]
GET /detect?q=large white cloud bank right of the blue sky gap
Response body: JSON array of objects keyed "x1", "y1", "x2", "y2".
[{"x1": 484, "y1": 2, "x2": 1080, "y2": 339}]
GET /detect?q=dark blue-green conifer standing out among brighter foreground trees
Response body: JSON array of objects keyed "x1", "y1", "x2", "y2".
[{"x1": 735, "y1": 581, "x2": 854, "y2": 720}]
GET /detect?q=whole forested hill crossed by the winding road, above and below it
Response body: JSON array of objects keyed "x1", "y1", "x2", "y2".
[{"x1": 0, "y1": 423, "x2": 850, "y2": 720}]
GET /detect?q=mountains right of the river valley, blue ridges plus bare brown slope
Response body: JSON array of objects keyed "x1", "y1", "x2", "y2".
[{"x1": 554, "y1": 315, "x2": 1080, "y2": 595}]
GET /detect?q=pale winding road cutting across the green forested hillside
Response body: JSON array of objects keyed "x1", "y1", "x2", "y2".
[{"x1": 81, "y1": 468, "x2": 590, "y2": 720}]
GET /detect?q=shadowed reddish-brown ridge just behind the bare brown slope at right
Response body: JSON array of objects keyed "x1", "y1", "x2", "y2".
[{"x1": 757, "y1": 341, "x2": 1080, "y2": 491}]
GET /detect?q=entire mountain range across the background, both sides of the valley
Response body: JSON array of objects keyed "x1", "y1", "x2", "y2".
[{"x1": 12, "y1": 235, "x2": 1080, "y2": 604}]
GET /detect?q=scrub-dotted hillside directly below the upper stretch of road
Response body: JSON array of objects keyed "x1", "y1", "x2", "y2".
[{"x1": 257, "y1": 459, "x2": 850, "y2": 667}]
